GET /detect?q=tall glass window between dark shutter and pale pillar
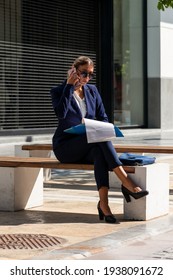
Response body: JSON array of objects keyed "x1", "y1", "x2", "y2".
[{"x1": 114, "y1": 0, "x2": 144, "y2": 126}]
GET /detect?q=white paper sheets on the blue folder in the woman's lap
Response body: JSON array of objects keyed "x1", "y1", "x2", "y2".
[{"x1": 83, "y1": 118, "x2": 116, "y2": 143}]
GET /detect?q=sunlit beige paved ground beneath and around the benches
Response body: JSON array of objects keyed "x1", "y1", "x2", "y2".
[{"x1": 0, "y1": 131, "x2": 173, "y2": 260}]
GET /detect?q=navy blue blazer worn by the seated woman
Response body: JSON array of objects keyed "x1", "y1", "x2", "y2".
[{"x1": 50, "y1": 80, "x2": 108, "y2": 149}]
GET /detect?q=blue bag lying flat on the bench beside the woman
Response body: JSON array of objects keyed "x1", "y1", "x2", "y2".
[{"x1": 119, "y1": 153, "x2": 156, "y2": 166}]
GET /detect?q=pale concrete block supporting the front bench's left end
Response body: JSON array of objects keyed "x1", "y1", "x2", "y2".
[{"x1": 0, "y1": 167, "x2": 43, "y2": 211}]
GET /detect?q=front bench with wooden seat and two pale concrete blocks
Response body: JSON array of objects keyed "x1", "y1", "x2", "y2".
[{"x1": 0, "y1": 156, "x2": 169, "y2": 220}]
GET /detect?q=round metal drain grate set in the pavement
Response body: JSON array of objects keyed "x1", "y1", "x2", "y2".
[{"x1": 0, "y1": 234, "x2": 63, "y2": 249}]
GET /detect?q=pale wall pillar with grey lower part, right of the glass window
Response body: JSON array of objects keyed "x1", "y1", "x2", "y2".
[{"x1": 147, "y1": 0, "x2": 173, "y2": 130}]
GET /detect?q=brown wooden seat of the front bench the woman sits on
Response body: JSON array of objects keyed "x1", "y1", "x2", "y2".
[{"x1": 0, "y1": 157, "x2": 135, "y2": 173}]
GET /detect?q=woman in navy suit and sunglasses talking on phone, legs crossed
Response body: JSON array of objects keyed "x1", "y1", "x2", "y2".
[{"x1": 51, "y1": 56, "x2": 148, "y2": 223}]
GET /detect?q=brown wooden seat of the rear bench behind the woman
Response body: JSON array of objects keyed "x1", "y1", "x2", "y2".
[{"x1": 22, "y1": 144, "x2": 173, "y2": 154}]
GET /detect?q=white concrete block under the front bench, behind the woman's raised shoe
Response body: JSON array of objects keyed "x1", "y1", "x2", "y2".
[{"x1": 111, "y1": 163, "x2": 169, "y2": 221}]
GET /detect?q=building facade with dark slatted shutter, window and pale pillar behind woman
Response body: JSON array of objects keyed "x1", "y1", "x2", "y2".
[{"x1": 0, "y1": 0, "x2": 173, "y2": 135}]
